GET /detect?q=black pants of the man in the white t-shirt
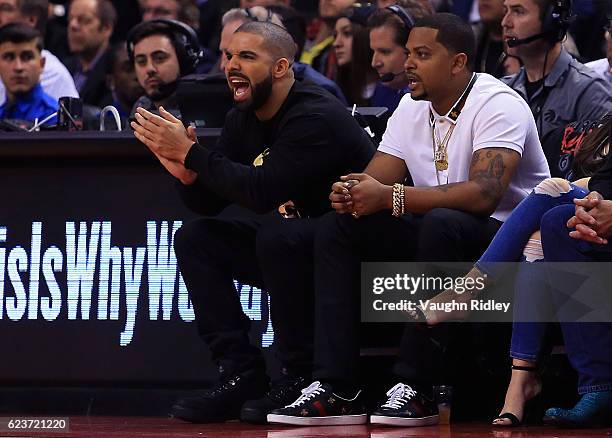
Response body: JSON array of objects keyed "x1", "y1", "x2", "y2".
[{"x1": 314, "y1": 208, "x2": 501, "y2": 384}]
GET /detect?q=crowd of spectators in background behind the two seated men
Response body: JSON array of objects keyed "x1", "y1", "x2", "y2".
[{"x1": 0, "y1": 0, "x2": 612, "y2": 128}]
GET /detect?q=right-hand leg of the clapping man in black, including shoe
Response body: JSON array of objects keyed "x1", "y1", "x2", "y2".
[{"x1": 240, "y1": 219, "x2": 317, "y2": 423}]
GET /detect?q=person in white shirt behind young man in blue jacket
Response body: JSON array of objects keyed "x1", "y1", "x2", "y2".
[{"x1": 0, "y1": 0, "x2": 79, "y2": 102}]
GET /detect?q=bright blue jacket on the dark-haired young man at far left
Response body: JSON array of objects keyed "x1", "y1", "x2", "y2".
[{"x1": 0, "y1": 83, "x2": 59, "y2": 125}]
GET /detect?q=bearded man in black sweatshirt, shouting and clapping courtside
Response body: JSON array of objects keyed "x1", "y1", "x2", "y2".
[{"x1": 132, "y1": 22, "x2": 374, "y2": 422}]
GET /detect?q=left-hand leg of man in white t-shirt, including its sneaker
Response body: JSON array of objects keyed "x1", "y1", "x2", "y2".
[{"x1": 268, "y1": 212, "x2": 418, "y2": 425}]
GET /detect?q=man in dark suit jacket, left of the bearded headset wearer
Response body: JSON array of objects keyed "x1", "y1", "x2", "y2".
[{"x1": 66, "y1": 0, "x2": 117, "y2": 107}]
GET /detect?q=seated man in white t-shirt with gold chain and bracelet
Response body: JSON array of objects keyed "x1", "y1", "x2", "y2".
[{"x1": 268, "y1": 14, "x2": 549, "y2": 426}]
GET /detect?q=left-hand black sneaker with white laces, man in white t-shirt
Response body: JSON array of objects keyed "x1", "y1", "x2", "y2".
[{"x1": 268, "y1": 382, "x2": 368, "y2": 426}]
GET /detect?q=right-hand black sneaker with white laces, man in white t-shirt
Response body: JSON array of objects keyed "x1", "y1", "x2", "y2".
[{"x1": 370, "y1": 383, "x2": 440, "y2": 426}]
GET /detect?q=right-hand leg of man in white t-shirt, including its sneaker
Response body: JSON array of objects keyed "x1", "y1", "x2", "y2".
[{"x1": 370, "y1": 208, "x2": 500, "y2": 426}]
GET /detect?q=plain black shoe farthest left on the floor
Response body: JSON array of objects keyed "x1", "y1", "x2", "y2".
[{"x1": 170, "y1": 371, "x2": 268, "y2": 423}]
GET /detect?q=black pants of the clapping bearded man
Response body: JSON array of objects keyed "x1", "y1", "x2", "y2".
[{"x1": 175, "y1": 208, "x2": 316, "y2": 375}]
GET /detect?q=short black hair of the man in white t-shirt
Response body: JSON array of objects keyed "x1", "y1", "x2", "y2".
[{"x1": 414, "y1": 12, "x2": 476, "y2": 71}]
